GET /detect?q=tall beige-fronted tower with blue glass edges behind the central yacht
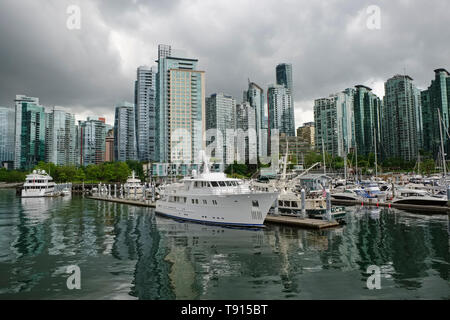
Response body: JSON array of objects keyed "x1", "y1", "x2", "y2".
[{"x1": 156, "y1": 45, "x2": 205, "y2": 163}]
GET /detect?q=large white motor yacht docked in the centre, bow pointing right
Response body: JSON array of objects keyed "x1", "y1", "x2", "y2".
[{"x1": 155, "y1": 155, "x2": 278, "y2": 227}]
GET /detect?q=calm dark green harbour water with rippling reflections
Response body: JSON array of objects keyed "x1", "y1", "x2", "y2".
[{"x1": 0, "y1": 190, "x2": 450, "y2": 299}]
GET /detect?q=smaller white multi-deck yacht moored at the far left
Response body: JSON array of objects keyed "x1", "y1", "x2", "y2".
[{"x1": 22, "y1": 170, "x2": 59, "y2": 198}]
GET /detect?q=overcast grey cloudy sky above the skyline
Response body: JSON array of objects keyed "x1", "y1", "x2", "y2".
[{"x1": 0, "y1": 0, "x2": 450, "y2": 126}]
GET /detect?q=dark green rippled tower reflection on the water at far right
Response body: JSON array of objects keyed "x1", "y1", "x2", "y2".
[{"x1": 344, "y1": 208, "x2": 448, "y2": 289}]
